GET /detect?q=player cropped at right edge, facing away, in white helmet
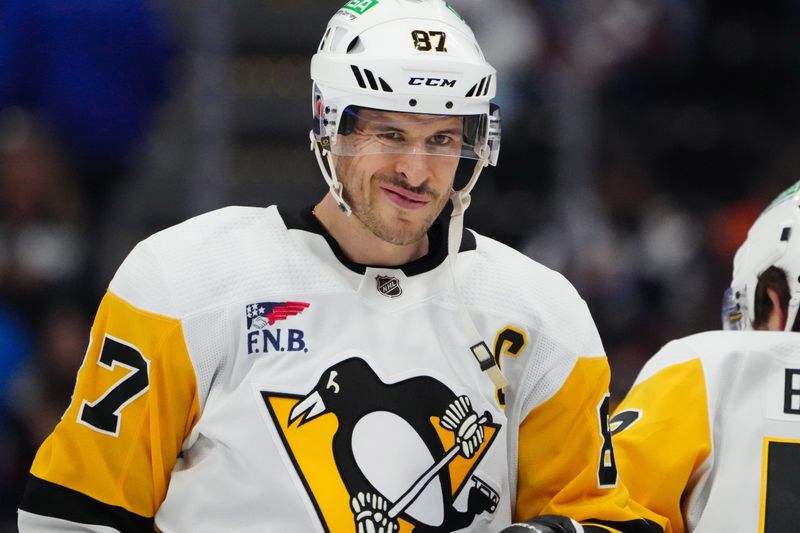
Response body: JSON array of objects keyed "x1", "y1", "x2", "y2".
[{"x1": 611, "y1": 182, "x2": 800, "y2": 533}]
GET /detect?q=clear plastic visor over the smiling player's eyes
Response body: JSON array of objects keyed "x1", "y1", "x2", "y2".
[{"x1": 331, "y1": 107, "x2": 499, "y2": 164}]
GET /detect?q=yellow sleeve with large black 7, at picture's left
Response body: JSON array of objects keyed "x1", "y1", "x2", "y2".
[{"x1": 19, "y1": 286, "x2": 200, "y2": 532}]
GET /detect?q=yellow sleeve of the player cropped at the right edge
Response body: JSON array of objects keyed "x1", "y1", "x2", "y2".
[{"x1": 612, "y1": 350, "x2": 712, "y2": 533}]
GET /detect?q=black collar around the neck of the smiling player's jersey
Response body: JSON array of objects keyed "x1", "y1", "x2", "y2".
[{"x1": 278, "y1": 206, "x2": 477, "y2": 276}]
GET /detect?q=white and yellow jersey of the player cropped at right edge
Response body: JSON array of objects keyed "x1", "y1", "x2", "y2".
[{"x1": 611, "y1": 331, "x2": 800, "y2": 533}]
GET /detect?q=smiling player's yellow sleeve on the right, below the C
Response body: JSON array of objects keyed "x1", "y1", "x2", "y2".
[{"x1": 514, "y1": 357, "x2": 664, "y2": 532}]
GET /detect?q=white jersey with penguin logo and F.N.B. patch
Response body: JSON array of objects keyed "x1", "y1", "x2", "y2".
[{"x1": 19, "y1": 206, "x2": 658, "y2": 533}]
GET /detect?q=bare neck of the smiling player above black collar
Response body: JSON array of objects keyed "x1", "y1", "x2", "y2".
[{"x1": 313, "y1": 194, "x2": 428, "y2": 266}]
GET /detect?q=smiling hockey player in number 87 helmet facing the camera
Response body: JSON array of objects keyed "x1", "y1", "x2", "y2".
[{"x1": 19, "y1": 0, "x2": 661, "y2": 533}]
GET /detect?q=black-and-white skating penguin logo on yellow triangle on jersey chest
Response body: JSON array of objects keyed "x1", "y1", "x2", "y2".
[{"x1": 261, "y1": 358, "x2": 500, "y2": 533}]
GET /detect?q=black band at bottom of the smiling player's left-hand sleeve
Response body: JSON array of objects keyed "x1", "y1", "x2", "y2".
[{"x1": 19, "y1": 474, "x2": 155, "y2": 533}]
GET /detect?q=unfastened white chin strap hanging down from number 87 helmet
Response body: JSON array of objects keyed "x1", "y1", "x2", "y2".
[{"x1": 447, "y1": 159, "x2": 508, "y2": 389}]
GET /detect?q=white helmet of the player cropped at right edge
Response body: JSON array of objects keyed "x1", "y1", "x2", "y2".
[{"x1": 722, "y1": 181, "x2": 800, "y2": 331}]
